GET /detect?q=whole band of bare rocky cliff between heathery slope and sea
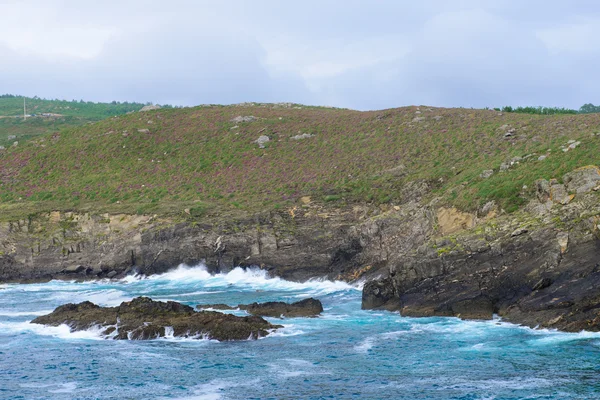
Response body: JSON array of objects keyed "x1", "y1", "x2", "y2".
[{"x1": 0, "y1": 166, "x2": 600, "y2": 331}]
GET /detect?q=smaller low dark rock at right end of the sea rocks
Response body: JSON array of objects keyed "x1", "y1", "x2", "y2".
[{"x1": 196, "y1": 298, "x2": 323, "y2": 318}]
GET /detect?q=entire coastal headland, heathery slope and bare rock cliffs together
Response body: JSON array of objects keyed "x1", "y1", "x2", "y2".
[{"x1": 0, "y1": 104, "x2": 600, "y2": 331}]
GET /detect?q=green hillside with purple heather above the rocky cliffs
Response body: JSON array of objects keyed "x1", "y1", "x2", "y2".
[{"x1": 0, "y1": 106, "x2": 600, "y2": 222}]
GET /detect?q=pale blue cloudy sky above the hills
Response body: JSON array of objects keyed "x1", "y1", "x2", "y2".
[{"x1": 0, "y1": 0, "x2": 600, "y2": 110}]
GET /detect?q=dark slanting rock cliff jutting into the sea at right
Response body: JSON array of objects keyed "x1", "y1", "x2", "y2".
[{"x1": 363, "y1": 167, "x2": 600, "y2": 331}]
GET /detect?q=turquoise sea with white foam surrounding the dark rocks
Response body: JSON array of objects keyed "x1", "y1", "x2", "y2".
[{"x1": 0, "y1": 266, "x2": 600, "y2": 399}]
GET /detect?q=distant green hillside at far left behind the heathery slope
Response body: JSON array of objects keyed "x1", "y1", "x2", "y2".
[{"x1": 0, "y1": 96, "x2": 144, "y2": 146}]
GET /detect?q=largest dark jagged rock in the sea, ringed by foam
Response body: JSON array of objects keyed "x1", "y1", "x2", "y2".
[{"x1": 31, "y1": 297, "x2": 281, "y2": 341}]
